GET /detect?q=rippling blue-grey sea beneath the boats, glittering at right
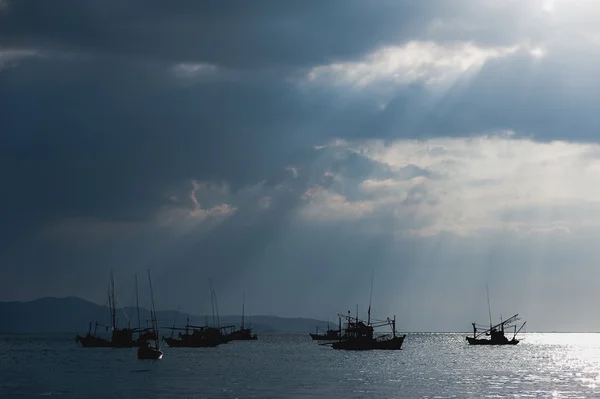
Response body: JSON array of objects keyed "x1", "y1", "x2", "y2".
[{"x1": 0, "y1": 333, "x2": 600, "y2": 399}]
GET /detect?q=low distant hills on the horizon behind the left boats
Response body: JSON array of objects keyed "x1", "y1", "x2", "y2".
[{"x1": 0, "y1": 297, "x2": 327, "y2": 335}]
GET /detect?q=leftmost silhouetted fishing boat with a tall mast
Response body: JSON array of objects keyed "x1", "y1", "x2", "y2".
[{"x1": 75, "y1": 270, "x2": 138, "y2": 348}]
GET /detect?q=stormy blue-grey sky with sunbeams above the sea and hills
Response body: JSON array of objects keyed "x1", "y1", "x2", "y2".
[{"x1": 0, "y1": 0, "x2": 600, "y2": 331}]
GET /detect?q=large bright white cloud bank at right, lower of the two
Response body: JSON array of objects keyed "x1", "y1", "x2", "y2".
[{"x1": 302, "y1": 134, "x2": 600, "y2": 236}]
